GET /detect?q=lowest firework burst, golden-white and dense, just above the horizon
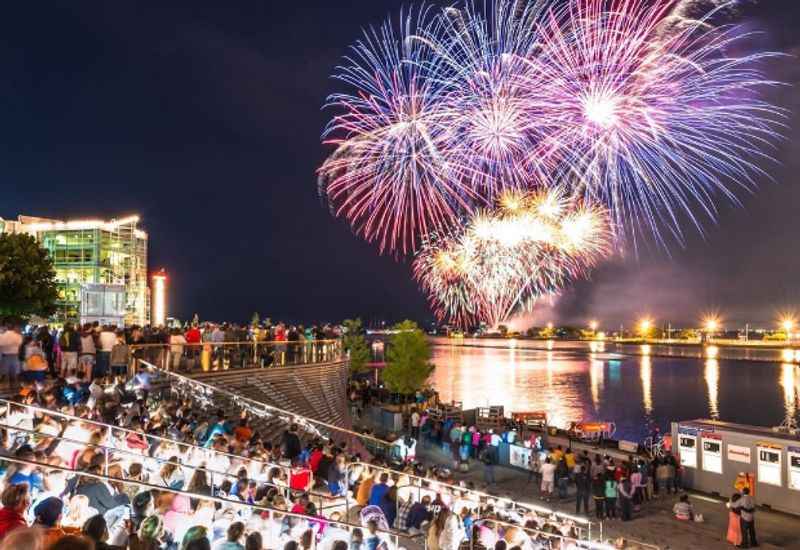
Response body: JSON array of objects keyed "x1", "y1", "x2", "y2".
[{"x1": 414, "y1": 187, "x2": 612, "y2": 326}]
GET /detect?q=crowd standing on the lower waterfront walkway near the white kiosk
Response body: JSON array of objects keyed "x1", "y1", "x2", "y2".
[{"x1": 392, "y1": 408, "x2": 758, "y2": 548}]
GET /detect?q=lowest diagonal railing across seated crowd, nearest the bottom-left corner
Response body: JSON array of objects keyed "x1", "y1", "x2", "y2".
[{"x1": 2, "y1": 457, "x2": 403, "y2": 550}]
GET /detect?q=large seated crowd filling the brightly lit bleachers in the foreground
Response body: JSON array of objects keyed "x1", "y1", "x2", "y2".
[{"x1": 0, "y1": 362, "x2": 592, "y2": 550}]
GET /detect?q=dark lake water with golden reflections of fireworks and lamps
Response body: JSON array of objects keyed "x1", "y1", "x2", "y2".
[{"x1": 431, "y1": 342, "x2": 800, "y2": 441}]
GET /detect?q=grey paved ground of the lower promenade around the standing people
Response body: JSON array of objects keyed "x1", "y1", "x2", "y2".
[{"x1": 417, "y1": 446, "x2": 800, "y2": 550}]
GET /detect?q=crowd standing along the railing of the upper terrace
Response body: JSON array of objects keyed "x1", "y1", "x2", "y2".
[{"x1": 0, "y1": 322, "x2": 342, "y2": 386}]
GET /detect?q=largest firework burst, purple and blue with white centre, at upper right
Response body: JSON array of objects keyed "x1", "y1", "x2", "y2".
[{"x1": 531, "y1": 0, "x2": 784, "y2": 242}]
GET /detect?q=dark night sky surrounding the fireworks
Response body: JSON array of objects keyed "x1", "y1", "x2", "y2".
[{"x1": 0, "y1": 0, "x2": 800, "y2": 323}]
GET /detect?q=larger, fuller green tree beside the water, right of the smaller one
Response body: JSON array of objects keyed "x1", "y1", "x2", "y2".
[{"x1": 382, "y1": 321, "x2": 434, "y2": 395}]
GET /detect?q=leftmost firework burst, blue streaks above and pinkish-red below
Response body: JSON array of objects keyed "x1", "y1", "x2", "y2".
[{"x1": 319, "y1": 10, "x2": 474, "y2": 253}]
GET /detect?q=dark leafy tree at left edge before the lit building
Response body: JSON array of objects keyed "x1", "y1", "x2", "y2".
[{"x1": 0, "y1": 234, "x2": 58, "y2": 321}]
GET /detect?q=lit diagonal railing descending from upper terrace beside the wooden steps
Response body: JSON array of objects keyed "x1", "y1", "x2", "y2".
[{"x1": 141, "y1": 361, "x2": 392, "y2": 456}]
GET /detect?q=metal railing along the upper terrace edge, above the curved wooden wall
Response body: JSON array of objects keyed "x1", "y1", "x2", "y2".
[{"x1": 129, "y1": 339, "x2": 344, "y2": 372}]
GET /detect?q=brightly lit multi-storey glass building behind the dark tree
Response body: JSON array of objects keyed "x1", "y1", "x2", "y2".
[{"x1": 0, "y1": 216, "x2": 150, "y2": 325}]
